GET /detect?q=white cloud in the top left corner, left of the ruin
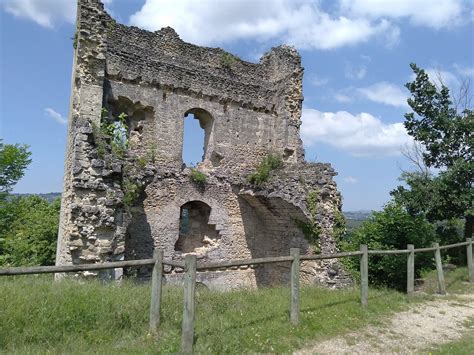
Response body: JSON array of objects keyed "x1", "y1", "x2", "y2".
[{"x1": 2, "y1": 0, "x2": 77, "y2": 28}]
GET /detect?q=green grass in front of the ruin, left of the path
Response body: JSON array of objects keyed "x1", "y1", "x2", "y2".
[{"x1": 0, "y1": 276, "x2": 418, "y2": 354}]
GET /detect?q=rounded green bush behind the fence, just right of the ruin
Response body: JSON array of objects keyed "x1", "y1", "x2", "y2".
[{"x1": 340, "y1": 202, "x2": 436, "y2": 290}]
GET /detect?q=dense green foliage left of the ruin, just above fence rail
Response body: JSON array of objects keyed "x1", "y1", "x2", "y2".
[{"x1": 0, "y1": 195, "x2": 61, "y2": 266}]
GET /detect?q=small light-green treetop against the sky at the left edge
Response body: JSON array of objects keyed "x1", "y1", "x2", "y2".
[{"x1": 0, "y1": 140, "x2": 31, "y2": 198}]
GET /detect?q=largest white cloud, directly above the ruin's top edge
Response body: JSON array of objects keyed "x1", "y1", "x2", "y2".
[{"x1": 130, "y1": 0, "x2": 392, "y2": 49}]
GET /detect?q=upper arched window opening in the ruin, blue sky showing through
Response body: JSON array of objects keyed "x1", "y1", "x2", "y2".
[{"x1": 181, "y1": 108, "x2": 214, "y2": 165}]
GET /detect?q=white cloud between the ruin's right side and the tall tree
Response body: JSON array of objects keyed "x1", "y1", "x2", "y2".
[{"x1": 301, "y1": 108, "x2": 412, "y2": 156}]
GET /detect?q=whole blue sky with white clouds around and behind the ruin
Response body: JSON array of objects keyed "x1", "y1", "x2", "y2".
[{"x1": 0, "y1": 0, "x2": 474, "y2": 210}]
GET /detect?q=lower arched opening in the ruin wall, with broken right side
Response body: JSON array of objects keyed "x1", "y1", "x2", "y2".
[{"x1": 174, "y1": 201, "x2": 220, "y2": 253}]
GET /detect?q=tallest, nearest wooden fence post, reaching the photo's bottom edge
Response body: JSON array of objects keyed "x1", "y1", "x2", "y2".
[{"x1": 181, "y1": 255, "x2": 196, "y2": 354}]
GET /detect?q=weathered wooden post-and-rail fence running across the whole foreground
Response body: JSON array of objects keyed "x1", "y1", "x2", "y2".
[{"x1": 0, "y1": 238, "x2": 474, "y2": 353}]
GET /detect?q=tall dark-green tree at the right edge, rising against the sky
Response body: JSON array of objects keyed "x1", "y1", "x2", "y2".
[{"x1": 391, "y1": 64, "x2": 474, "y2": 238}]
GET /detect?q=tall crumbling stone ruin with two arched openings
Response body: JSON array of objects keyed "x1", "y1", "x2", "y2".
[{"x1": 56, "y1": 0, "x2": 347, "y2": 289}]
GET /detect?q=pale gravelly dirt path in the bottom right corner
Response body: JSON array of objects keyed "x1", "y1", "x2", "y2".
[{"x1": 295, "y1": 295, "x2": 474, "y2": 354}]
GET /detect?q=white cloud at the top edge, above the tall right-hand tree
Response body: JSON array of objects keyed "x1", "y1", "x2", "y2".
[{"x1": 341, "y1": 0, "x2": 466, "y2": 29}]
